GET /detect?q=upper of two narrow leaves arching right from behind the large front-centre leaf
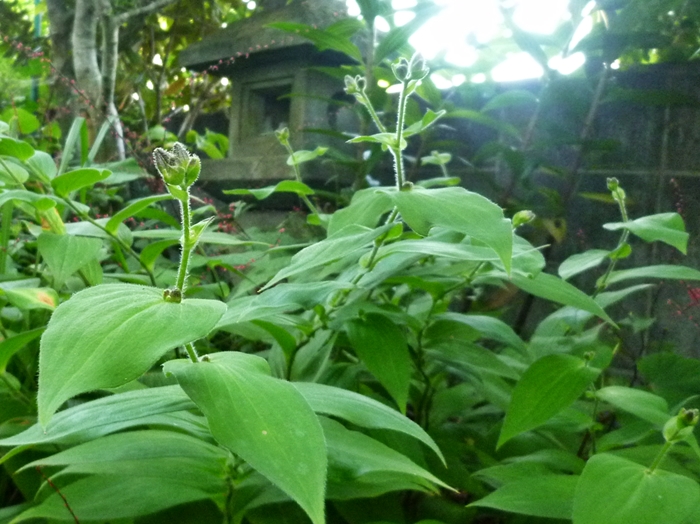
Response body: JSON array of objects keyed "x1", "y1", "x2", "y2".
[{"x1": 292, "y1": 382, "x2": 445, "y2": 463}]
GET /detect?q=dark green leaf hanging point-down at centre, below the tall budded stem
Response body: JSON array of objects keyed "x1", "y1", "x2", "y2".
[{"x1": 346, "y1": 313, "x2": 411, "y2": 413}]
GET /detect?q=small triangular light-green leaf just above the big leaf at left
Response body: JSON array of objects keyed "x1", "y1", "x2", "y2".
[{"x1": 37, "y1": 233, "x2": 102, "y2": 289}]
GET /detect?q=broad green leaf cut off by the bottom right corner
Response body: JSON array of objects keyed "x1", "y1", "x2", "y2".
[{"x1": 573, "y1": 453, "x2": 700, "y2": 524}]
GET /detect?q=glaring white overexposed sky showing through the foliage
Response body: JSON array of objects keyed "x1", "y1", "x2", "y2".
[{"x1": 346, "y1": 0, "x2": 595, "y2": 89}]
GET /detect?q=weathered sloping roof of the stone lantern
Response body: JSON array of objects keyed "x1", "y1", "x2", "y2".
[{"x1": 179, "y1": 0, "x2": 347, "y2": 76}]
